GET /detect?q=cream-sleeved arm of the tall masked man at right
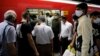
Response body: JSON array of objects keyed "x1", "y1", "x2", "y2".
[{"x1": 81, "y1": 21, "x2": 92, "y2": 56}]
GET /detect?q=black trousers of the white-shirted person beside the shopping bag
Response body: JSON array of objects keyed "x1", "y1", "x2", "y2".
[{"x1": 61, "y1": 37, "x2": 69, "y2": 54}]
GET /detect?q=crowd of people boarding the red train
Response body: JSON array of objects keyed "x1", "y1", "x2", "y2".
[{"x1": 0, "y1": 3, "x2": 100, "y2": 56}]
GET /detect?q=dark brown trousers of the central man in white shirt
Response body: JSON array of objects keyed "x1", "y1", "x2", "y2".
[{"x1": 37, "y1": 44, "x2": 52, "y2": 56}]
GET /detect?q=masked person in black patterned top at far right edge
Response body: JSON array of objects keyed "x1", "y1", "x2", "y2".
[{"x1": 90, "y1": 11, "x2": 100, "y2": 55}]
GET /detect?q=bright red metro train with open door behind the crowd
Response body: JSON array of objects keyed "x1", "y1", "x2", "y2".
[{"x1": 0, "y1": 0, "x2": 100, "y2": 23}]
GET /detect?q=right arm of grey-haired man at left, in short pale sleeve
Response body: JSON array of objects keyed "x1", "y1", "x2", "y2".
[{"x1": 6, "y1": 27, "x2": 17, "y2": 56}]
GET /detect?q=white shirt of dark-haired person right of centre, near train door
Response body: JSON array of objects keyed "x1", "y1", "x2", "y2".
[{"x1": 61, "y1": 21, "x2": 72, "y2": 40}]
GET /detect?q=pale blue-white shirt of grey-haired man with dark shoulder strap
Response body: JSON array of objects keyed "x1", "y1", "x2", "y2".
[{"x1": 0, "y1": 20, "x2": 16, "y2": 43}]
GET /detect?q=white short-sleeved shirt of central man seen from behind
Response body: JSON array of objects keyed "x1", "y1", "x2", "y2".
[{"x1": 33, "y1": 23, "x2": 54, "y2": 44}]
